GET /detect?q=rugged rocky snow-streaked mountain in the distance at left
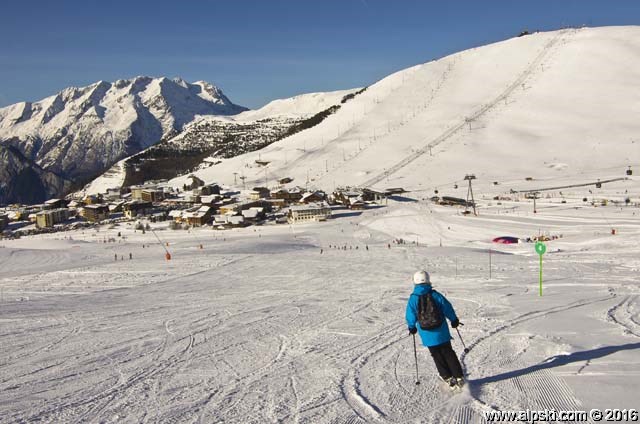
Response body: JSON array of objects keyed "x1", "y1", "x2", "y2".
[{"x1": 0, "y1": 77, "x2": 246, "y2": 202}]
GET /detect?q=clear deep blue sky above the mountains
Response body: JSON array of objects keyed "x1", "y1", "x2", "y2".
[{"x1": 0, "y1": 0, "x2": 640, "y2": 108}]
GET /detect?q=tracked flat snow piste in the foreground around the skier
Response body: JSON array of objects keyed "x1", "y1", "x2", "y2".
[{"x1": 0, "y1": 197, "x2": 640, "y2": 423}]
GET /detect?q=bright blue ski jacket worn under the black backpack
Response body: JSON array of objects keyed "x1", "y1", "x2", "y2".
[{"x1": 405, "y1": 284, "x2": 457, "y2": 347}]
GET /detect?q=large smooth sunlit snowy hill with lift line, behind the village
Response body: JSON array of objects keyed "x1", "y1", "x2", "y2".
[{"x1": 172, "y1": 27, "x2": 640, "y2": 196}]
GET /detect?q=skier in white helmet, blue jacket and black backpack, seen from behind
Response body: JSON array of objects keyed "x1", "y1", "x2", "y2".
[{"x1": 405, "y1": 271, "x2": 464, "y2": 387}]
